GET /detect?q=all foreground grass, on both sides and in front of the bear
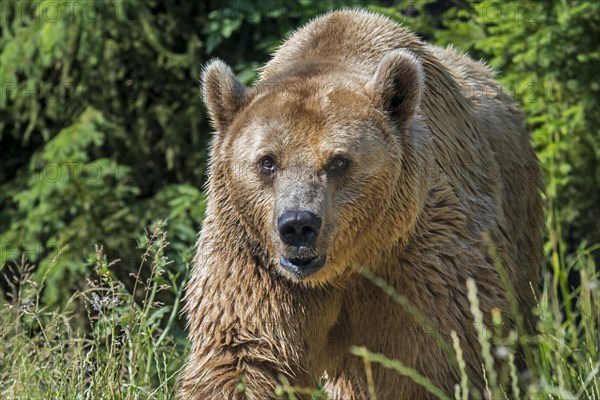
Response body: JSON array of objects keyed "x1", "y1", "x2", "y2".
[{"x1": 0, "y1": 219, "x2": 600, "y2": 400}]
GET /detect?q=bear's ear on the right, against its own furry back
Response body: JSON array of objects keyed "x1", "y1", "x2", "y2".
[{"x1": 366, "y1": 49, "x2": 425, "y2": 127}]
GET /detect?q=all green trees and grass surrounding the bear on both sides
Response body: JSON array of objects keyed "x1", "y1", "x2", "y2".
[{"x1": 0, "y1": 0, "x2": 600, "y2": 399}]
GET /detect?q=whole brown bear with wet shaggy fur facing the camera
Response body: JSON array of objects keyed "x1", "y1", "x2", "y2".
[{"x1": 182, "y1": 10, "x2": 543, "y2": 400}]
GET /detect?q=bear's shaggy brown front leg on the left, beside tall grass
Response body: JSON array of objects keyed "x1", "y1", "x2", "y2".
[{"x1": 182, "y1": 239, "x2": 314, "y2": 400}]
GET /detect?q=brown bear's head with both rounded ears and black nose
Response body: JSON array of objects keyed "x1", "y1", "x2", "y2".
[{"x1": 202, "y1": 50, "x2": 428, "y2": 285}]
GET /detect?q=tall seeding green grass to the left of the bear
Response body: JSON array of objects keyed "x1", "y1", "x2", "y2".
[{"x1": 0, "y1": 224, "x2": 188, "y2": 399}]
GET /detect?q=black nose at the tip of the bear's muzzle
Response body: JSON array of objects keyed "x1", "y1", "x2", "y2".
[{"x1": 277, "y1": 211, "x2": 321, "y2": 247}]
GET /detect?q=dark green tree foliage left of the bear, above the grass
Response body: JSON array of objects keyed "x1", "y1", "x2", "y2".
[{"x1": 0, "y1": 1, "x2": 207, "y2": 305}]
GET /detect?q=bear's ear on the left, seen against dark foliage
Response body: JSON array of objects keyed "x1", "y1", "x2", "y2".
[{"x1": 202, "y1": 59, "x2": 249, "y2": 133}]
